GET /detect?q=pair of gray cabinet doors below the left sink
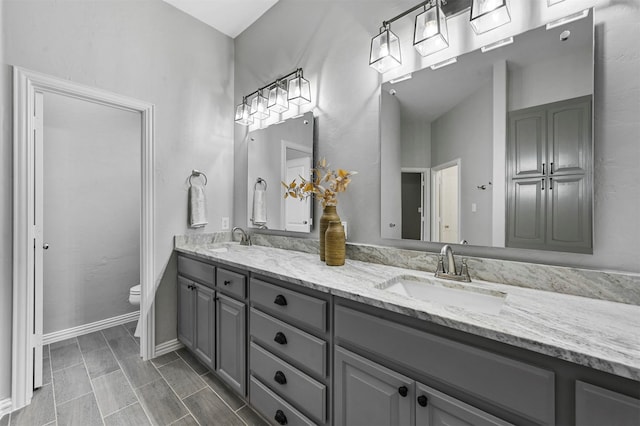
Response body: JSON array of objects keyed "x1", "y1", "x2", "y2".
[{"x1": 178, "y1": 277, "x2": 216, "y2": 369}]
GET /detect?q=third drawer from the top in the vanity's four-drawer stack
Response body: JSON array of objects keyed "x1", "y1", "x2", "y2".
[{"x1": 250, "y1": 343, "x2": 327, "y2": 423}]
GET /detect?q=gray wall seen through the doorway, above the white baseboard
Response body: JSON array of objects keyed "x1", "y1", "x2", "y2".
[{"x1": 43, "y1": 93, "x2": 142, "y2": 334}]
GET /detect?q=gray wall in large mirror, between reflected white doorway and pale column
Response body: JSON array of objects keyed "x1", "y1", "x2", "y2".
[{"x1": 431, "y1": 81, "x2": 493, "y2": 246}]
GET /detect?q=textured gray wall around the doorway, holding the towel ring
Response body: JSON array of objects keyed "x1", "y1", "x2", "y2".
[{"x1": 0, "y1": 0, "x2": 234, "y2": 399}]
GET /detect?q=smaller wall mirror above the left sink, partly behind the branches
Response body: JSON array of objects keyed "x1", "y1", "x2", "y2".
[{"x1": 247, "y1": 112, "x2": 313, "y2": 232}]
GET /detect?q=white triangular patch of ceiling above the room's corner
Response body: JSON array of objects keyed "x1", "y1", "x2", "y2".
[{"x1": 164, "y1": 0, "x2": 278, "y2": 38}]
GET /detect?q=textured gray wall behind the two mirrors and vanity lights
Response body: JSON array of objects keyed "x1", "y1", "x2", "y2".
[{"x1": 234, "y1": 0, "x2": 640, "y2": 272}]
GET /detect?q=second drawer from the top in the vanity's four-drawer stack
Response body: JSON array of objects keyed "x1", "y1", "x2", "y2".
[{"x1": 251, "y1": 308, "x2": 327, "y2": 377}]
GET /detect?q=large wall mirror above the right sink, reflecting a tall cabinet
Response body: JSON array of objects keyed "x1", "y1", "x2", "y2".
[{"x1": 380, "y1": 9, "x2": 594, "y2": 253}]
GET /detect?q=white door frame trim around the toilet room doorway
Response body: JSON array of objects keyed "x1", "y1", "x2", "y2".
[{"x1": 11, "y1": 66, "x2": 155, "y2": 410}]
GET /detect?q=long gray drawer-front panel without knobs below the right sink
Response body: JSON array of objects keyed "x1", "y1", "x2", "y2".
[{"x1": 335, "y1": 306, "x2": 555, "y2": 424}]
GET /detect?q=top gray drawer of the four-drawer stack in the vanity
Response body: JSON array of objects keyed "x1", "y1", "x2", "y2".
[{"x1": 251, "y1": 278, "x2": 327, "y2": 333}]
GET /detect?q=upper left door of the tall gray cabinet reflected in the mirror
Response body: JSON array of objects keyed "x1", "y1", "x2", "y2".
[{"x1": 509, "y1": 107, "x2": 547, "y2": 178}]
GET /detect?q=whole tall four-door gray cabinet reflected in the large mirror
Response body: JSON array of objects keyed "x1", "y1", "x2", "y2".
[{"x1": 506, "y1": 96, "x2": 592, "y2": 253}]
